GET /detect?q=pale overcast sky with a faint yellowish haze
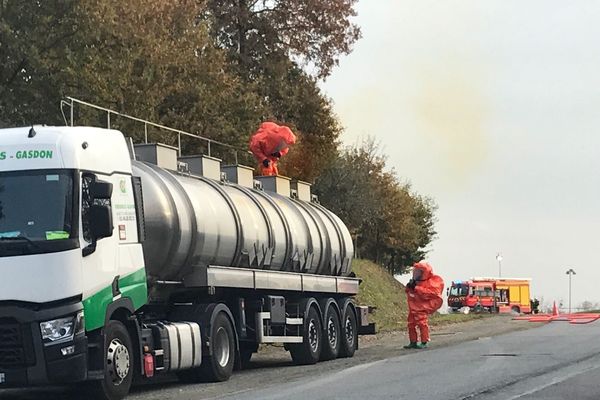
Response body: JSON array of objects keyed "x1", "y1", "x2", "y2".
[{"x1": 322, "y1": 0, "x2": 600, "y2": 307}]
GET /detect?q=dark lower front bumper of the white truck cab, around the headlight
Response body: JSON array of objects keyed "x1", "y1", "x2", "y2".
[{"x1": 0, "y1": 302, "x2": 88, "y2": 389}]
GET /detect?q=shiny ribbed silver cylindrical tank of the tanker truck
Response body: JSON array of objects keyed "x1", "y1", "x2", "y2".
[{"x1": 133, "y1": 161, "x2": 354, "y2": 280}]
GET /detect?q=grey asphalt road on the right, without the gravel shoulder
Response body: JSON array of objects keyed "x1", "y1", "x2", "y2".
[{"x1": 217, "y1": 322, "x2": 600, "y2": 400}]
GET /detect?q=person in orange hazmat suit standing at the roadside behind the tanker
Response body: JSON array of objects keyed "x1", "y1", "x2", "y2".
[{"x1": 404, "y1": 261, "x2": 444, "y2": 349}]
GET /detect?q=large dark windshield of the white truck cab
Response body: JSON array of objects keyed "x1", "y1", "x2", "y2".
[{"x1": 0, "y1": 170, "x2": 79, "y2": 257}]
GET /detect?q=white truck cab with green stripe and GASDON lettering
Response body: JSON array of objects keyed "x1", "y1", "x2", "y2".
[{"x1": 0, "y1": 126, "x2": 147, "y2": 384}]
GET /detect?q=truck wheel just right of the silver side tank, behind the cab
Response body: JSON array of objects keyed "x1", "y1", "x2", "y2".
[{"x1": 177, "y1": 312, "x2": 236, "y2": 383}]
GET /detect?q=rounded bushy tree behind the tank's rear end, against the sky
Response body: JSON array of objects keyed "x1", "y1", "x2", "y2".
[{"x1": 315, "y1": 139, "x2": 436, "y2": 273}]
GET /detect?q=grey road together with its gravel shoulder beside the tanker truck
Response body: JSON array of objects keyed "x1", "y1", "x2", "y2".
[{"x1": 0, "y1": 319, "x2": 600, "y2": 400}]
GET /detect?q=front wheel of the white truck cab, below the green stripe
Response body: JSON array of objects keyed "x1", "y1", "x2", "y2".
[{"x1": 90, "y1": 320, "x2": 134, "y2": 400}]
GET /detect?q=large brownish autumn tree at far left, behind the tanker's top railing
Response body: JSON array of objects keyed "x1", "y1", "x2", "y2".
[{"x1": 0, "y1": 0, "x2": 264, "y2": 155}]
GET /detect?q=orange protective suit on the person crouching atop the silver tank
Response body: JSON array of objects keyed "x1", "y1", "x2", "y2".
[{"x1": 250, "y1": 122, "x2": 296, "y2": 175}]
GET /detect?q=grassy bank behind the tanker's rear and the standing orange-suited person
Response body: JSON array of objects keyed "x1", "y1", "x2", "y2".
[{"x1": 352, "y1": 260, "x2": 487, "y2": 332}]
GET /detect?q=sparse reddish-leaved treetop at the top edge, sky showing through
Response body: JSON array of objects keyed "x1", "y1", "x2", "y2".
[{"x1": 205, "y1": 0, "x2": 361, "y2": 78}]
